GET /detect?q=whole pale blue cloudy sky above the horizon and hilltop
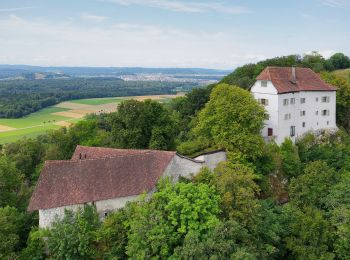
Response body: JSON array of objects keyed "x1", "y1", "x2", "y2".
[{"x1": 0, "y1": 0, "x2": 350, "y2": 69}]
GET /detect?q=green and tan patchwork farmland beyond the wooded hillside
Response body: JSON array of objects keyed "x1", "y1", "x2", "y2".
[{"x1": 0, "y1": 94, "x2": 182, "y2": 144}]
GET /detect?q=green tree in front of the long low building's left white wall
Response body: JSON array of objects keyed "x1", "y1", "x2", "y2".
[{"x1": 48, "y1": 206, "x2": 100, "y2": 260}]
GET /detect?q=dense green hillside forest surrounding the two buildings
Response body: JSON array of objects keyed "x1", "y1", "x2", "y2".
[{"x1": 0, "y1": 52, "x2": 350, "y2": 259}]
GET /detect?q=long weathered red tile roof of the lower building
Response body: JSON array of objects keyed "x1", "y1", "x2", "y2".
[{"x1": 28, "y1": 146, "x2": 176, "y2": 211}]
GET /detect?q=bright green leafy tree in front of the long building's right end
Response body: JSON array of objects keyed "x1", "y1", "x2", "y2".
[{"x1": 127, "y1": 181, "x2": 220, "y2": 259}]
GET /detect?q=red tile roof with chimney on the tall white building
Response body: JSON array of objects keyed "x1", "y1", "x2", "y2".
[{"x1": 256, "y1": 67, "x2": 336, "y2": 94}]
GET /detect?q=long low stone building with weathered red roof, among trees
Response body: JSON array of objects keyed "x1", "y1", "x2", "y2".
[{"x1": 28, "y1": 146, "x2": 226, "y2": 228}]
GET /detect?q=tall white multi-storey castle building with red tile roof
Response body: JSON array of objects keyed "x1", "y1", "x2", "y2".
[{"x1": 251, "y1": 67, "x2": 336, "y2": 144}]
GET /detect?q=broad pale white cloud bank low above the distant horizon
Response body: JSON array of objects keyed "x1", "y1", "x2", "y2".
[{"x1": 0, "y1": 14, "x2": 349, "y2": 69}]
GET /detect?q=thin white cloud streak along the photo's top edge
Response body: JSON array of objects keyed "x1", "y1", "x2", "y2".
[{"x1": 101, "y1": 0, "x2": 250, "y2": 14}]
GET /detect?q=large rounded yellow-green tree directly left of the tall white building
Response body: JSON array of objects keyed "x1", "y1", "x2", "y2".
[{"x1": 193, "y1": 84, "x2": 265, "y2": 158}]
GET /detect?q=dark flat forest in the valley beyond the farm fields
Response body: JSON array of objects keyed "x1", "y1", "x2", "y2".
[{"x1": 0, "y1": 78, "x2": 198, "y2": 118}]
